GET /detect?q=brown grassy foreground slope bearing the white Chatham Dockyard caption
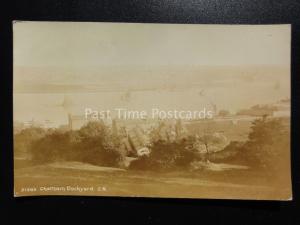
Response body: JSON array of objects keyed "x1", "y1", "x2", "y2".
[{"x1": 15, "y1": 162, "x2": 291, "y2": 200}]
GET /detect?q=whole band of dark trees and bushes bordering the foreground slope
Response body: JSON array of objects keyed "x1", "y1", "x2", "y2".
[{"x1": 14, "y1": 118, "x2": 290, "y2": 171}]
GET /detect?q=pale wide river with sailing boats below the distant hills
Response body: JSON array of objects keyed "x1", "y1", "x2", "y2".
[{"x1": 14, "y1": 85, "x2": 285, "y2": 126}]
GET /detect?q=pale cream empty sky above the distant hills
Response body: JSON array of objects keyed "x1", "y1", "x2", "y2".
[{"x1": 13, "y1": 21, "x2": 291, "y2": 68}]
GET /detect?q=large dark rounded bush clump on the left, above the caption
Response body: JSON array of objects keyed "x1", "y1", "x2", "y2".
[{"x1": 31, "y1": 122, "x2": 123, "y2": 166}]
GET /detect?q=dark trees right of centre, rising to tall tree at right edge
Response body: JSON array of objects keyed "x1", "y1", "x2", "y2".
[{"x1": 130, "y1": 117, "x2": 290, "y2": 174}]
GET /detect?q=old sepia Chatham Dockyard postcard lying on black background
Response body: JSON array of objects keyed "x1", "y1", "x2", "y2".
[{"x1": 13, "y1": 21, "x2": 292, "y2": 200}]
